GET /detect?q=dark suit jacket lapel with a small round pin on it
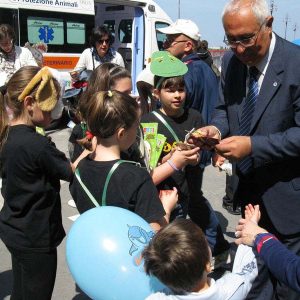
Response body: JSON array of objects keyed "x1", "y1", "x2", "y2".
[{"x1": 250, "y1": 36, "x2": 283, "y2": 134}]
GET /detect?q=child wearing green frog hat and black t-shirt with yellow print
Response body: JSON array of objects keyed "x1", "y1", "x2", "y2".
[{"x1": 142, "y1": 51, "x2": 204, "y2": 220}]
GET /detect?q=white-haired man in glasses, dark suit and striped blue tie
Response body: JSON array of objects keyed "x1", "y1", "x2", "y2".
[{"x1": 193, "y1": 0, "x2": 300, "y2": 300}]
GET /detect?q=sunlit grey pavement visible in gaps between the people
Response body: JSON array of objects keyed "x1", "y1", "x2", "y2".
[{"x1": 0, "y1": 128, "x2": 239, "y2": 300}]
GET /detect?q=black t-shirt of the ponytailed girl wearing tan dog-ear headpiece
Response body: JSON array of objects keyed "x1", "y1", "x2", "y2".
[{"x1": 0, "y1": 125, "x2": 73, "y2": 251}]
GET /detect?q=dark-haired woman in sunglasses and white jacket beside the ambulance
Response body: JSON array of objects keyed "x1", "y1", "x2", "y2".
[{"x1": 71, "y1": 25, "x2": 125, "y2": 79}]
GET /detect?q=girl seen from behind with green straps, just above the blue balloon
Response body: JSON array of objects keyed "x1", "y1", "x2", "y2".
[{"x1": 70, "y1": 91, "x2": 177, "y2": 230}]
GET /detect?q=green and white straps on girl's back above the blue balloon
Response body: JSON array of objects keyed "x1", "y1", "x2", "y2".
[{"x1": 75, "y1": 159, "x2": 140, "y2": 207}]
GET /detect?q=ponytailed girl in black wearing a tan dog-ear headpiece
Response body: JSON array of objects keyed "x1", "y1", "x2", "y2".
[{"x1": 0, "y1": 67, "x2": 85, "y2": 300}]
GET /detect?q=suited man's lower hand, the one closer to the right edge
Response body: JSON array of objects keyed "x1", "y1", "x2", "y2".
[{"x1": 215, "y1": 136, "x2": 252, "y2": 160}]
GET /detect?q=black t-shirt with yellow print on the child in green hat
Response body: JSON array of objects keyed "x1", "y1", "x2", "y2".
[{"x1": 141, "y1": 109, "x2": 204, "y2": 216}]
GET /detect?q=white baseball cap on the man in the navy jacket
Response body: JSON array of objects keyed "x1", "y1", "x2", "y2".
[{"x1": 157, "y1": 19, "x2": 201, "y2": 41}]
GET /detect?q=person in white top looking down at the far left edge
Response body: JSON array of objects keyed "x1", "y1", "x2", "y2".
[{"x1": 0, "y1": 24, "x2": 37, "y2": 86}]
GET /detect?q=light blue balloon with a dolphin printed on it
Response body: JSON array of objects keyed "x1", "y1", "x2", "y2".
[{"x1": 66, "y1": 206, "x2": 166, "y2": 300}]
